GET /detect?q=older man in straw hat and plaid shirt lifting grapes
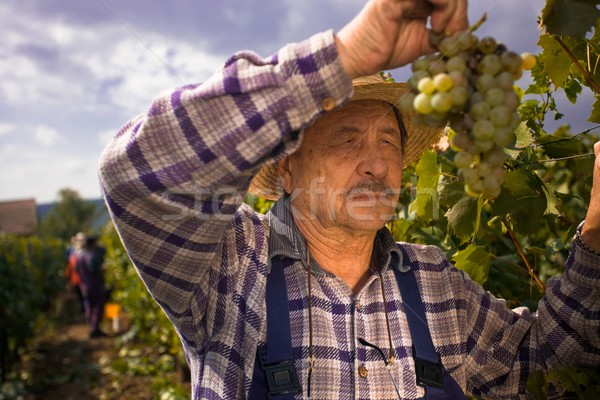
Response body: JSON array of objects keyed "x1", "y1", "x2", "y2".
[{"x1": 101, "y1": 0, "x2": 600, "y2": 399}]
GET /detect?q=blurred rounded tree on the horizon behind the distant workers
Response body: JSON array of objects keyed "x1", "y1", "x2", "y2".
[{"x1": 38, "y1": 188, "x2": 96, "y2": 240}]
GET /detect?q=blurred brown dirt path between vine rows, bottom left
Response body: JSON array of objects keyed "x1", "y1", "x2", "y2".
[{"x1": 12, "y1": 300, "x2": 162, "y2": 400}]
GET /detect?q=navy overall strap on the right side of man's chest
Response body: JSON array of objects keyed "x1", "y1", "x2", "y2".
[{"x1": 393, "y1": 248, "x2": 447, "y2": 399}]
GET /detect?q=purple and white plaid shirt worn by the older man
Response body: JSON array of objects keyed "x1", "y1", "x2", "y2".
[{"x1": 100, "y1": 32, "x2": 600, "y2": 399}]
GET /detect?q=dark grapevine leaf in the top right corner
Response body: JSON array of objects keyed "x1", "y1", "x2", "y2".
[{"x1": 542, "y1": 0, "x2": 600, "y2": 36}]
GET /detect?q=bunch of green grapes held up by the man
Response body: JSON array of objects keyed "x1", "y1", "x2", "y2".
[{"x1": 400, "y1": 30, "x2": 535, "y2": 199}]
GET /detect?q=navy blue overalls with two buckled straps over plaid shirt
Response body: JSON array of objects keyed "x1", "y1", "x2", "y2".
[{"x1": 248, "y1": 247, "x2": 466, "y2": 400}]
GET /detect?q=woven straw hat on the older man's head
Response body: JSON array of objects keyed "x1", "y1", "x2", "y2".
[{"x1": 249, "y1": 73, "x2": 443, "y2": 200}]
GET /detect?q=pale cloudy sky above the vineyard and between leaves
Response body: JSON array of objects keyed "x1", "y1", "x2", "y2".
[{"x1": 0, "y1": 0, "x2": 589, "y2": 203}]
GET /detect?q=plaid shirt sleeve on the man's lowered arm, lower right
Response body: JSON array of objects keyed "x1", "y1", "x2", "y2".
[{"x1": 459, "y1": 244, "x2": 600, "y2": 399}]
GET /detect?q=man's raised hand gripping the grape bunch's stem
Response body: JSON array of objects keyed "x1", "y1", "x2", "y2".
[{"x1": 336, "y1": 0, "x2": 468, "y2": 78}]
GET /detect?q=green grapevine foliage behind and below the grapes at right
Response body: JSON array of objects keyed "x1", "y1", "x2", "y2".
[{"x1": 389, "y1": 4, "x2": 600, "y2": 399}]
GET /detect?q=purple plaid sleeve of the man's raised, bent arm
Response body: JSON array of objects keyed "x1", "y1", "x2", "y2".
[{"x1": 100, "y1": 31, "x2": 352, "y2": 344}]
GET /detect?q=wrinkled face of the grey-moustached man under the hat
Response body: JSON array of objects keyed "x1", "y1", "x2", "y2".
[{"x1": 278, "y1": 100, "x2": 403, "y2": 231}]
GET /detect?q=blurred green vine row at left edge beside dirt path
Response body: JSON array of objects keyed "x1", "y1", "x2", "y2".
[{"x1": 0, "y1": 235, "x2": 65, "y2": 383}]
